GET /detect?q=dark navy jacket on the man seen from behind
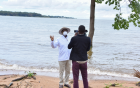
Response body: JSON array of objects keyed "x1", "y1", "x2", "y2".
[{"x1": 68, "y1": 34, "x2": 90, "y2": 61}]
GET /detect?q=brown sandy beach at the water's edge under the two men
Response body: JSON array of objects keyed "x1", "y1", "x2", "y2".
[{"x1": 0, "y1": 75, "x2": 140, "y2": 88}]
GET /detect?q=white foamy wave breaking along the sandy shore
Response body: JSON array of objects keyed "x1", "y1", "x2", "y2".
[{"x1": 0, "y1": 63, "x2": 137, "y2": 80}]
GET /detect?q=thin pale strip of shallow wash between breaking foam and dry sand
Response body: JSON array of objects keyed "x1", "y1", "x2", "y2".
[{"x1": 0, "y1": 69, "x2": 140, "y2": 81}]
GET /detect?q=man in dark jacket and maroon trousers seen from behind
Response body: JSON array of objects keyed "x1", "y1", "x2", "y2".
[{"x1": 68, "y1": 25, "x2": 90, "y2": 88}]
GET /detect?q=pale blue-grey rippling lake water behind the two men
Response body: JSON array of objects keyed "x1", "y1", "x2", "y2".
[{"x1": 0, "y1": 16, "x2": 140, "y2": 77}]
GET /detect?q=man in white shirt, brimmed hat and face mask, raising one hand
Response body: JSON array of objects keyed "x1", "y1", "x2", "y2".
[{"x1": 50, "y1": 27, "x2": 71, "y2": 88}]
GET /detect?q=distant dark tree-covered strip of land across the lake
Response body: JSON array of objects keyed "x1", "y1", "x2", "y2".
[{"x1": 0, "y1": 11, "x2": 75, "y2": 19}]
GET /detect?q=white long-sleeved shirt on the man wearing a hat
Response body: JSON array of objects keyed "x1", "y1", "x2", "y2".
[{"x1": 51, "y1": 35, "x2": 71, "y2": 61}]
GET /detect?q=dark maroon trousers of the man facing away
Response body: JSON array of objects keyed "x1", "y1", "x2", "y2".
[{"x1": 72, "y1": 61, "x2": 88, "y2": 88}]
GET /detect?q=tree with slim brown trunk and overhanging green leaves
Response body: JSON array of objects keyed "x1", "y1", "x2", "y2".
[{"x1": 88, "y1": 0, "x2": 140, "y2": 46}]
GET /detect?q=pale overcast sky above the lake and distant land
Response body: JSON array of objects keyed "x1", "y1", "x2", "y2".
[{"x1": 0, "y1": 0, "x2": 130, "y2": 19}]
